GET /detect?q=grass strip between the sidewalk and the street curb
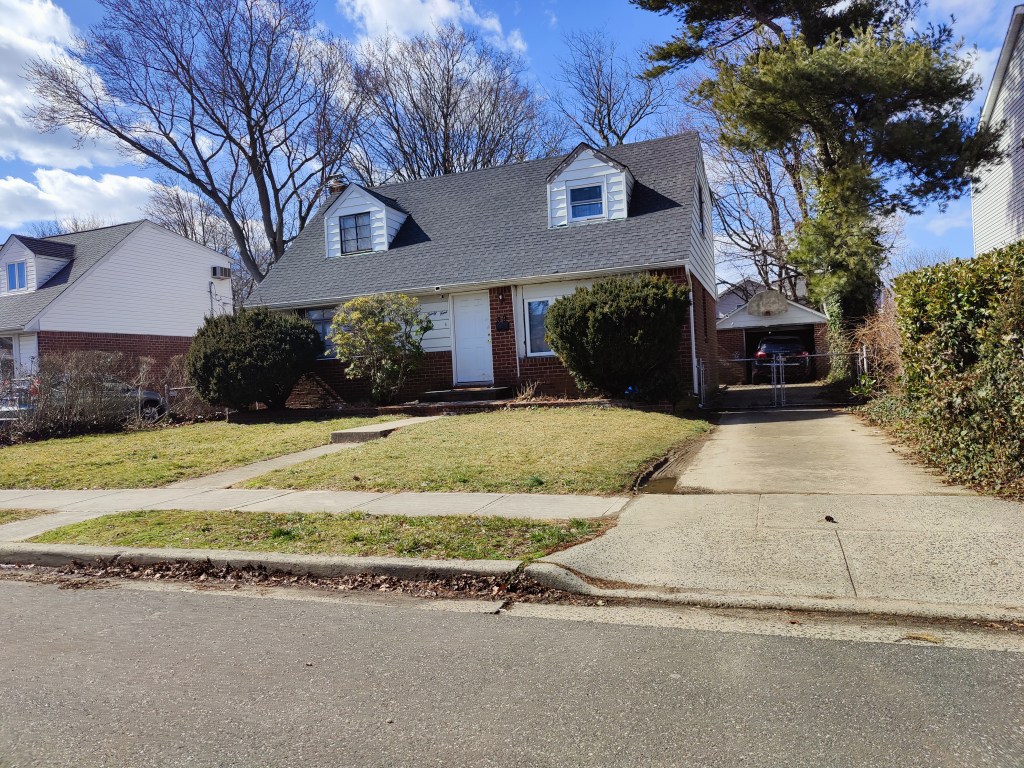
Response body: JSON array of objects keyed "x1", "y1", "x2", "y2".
[{"x1": 31, "y1": 510, "x2": 611, "y2": 560}]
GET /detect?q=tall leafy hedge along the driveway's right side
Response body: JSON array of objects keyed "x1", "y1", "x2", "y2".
[{"x1": 871, "y1": 243, "x2": 1024, "y2": 495}]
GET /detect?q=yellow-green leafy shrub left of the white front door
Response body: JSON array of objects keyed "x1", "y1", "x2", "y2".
[{"x1": 331, "y1": 293, "x2": 433, "y2": 403}]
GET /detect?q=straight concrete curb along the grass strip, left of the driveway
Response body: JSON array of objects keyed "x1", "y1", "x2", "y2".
[{"x1": 0, "y1": 544, "x2": 522, "y2": 580}]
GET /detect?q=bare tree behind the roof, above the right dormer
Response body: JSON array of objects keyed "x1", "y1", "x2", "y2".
[{"x1": 551, "y1": 30, "x2": 669, "y2": 146}]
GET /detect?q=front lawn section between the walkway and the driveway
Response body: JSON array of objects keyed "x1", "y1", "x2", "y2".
[{"x1": 245, "y1": 408, "x2": 710, "y2": 495}]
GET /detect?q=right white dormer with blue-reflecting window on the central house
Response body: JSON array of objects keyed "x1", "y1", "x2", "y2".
[{"x1": 548, "y1": 143, "x2": 633, "y2": 227}]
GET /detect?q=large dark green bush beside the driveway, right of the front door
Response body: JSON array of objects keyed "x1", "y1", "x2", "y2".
[{"x1": 545, "y1": 274, "x2": 690, "y2": 400}]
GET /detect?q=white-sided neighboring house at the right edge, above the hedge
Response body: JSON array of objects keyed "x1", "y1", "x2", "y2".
[{"x1": 971, "y1": 5, "x2": 1024, "y2": 255}]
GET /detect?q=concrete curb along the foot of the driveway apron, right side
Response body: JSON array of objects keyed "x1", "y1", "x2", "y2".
[{"x1": 523, "y1": 562, "x2": 1024, "y2": 622}]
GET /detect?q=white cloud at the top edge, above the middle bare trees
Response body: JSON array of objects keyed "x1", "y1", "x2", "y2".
[{"x1": 338, "y1": 0, "x2": 526, "y2": 52}]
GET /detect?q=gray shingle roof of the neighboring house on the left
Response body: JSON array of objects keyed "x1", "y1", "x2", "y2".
[{"x1": 0, "y1": 221, "x2": 143, "y2": 331}]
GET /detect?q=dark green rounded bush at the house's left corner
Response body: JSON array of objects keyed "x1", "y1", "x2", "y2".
[{"x1": 185, "y1": 307, "x2": 324, "y2": 410}]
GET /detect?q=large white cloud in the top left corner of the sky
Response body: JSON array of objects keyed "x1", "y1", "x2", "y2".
[{"x1": 0, "y1": 0, "x2": 123, "y2": 169}]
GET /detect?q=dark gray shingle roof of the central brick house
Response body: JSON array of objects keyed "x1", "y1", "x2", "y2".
[{"x1": 250, "y1": 133, "x2": 699, "y2": 306}]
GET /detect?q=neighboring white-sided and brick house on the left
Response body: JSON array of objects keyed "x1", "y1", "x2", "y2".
[{"x1": 0, "y1": 221, "x2": 232, "y2": 380}]
